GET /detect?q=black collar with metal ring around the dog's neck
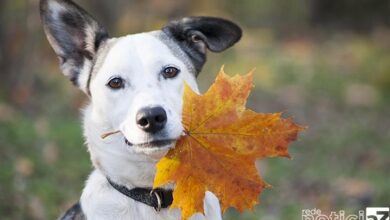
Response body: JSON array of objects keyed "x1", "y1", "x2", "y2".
[{"x1": 107, "y1": 178, "x2": 173, "y2": 211}]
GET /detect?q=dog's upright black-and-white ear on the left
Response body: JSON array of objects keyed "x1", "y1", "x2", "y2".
[{"x1": 40, "y1": 0, "x2": 108, "y2": 92}]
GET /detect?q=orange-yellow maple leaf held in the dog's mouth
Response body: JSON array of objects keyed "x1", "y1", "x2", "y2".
[{"x1": 154, "y1": 69, "x2": 304, "y2": 219}]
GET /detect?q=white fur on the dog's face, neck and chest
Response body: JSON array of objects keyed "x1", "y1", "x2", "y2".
[{"x1": 81, "y1": 32, "x2": 221, "y2": 220}]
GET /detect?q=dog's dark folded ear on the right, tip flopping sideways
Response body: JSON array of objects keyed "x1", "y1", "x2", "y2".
[{"x1": 163, "y1": 17, "x2": 242, "y2": 71}]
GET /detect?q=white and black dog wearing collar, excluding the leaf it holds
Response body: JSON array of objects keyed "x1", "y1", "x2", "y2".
[{"x1": 40, "y1": 0, "x2": 241, "y2": 220}]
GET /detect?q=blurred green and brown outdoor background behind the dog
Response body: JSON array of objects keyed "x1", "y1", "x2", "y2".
[{"x1": 0, "y1": 0, "x2": 390, "y2": 220}]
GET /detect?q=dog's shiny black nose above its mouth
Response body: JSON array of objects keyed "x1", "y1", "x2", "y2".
[{"x1": 136, "y1": 107, "x2": 167, "y2": 133}]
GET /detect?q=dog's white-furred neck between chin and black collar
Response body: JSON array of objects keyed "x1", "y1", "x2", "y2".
[{"x1": 84, "y1": 105, "x2": 166, "y2": 188}]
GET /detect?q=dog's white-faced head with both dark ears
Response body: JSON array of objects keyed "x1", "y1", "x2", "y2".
[{"x1": 40, "y1": 0, "x2": 241, "y2": 177}]
